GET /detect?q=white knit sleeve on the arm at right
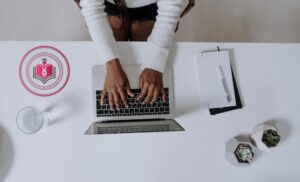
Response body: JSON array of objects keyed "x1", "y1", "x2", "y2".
[{"x1": 143, "y1": 0, "x2": 183, "y2": 73}]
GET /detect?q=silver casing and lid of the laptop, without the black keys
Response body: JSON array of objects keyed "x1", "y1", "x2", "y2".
[{"x1": 86, "y1": 64, "x2": 184, "y2": 134}]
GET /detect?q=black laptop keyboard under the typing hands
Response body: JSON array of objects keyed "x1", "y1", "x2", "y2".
[{"x1": 96, "y1": 88, "x2": 170, "y2": 117}]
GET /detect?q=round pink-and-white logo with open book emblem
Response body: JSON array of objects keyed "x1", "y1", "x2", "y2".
[{"x1": 19, "y1": 46, "x2": 70, "y2": 97}]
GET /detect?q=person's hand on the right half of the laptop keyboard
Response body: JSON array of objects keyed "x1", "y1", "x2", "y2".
[{"x1": 137, "y1": 68, "x2": 166, "y2": 105}]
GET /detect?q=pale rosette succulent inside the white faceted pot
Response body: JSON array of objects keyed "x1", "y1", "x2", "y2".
[{"x1": 235, "y1": 144, "x2": 254, "y2": 163}]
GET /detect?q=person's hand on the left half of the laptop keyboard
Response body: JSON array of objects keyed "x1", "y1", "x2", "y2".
[{"x1": 101, "y1": 59, "x2": 134, "y2": 111}]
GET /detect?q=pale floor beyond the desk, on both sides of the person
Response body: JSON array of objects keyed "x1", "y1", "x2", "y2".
[{"x1": 0, "y1": 0, "x2": 300, "y2": 42}]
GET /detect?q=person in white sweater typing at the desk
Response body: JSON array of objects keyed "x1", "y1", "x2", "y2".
[{"x1": 80, "y1": 0, "x2": 183, "y2": 111}]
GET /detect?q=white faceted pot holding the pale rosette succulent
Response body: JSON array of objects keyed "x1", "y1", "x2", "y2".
[{"x1": 225, "y1": 137, "x2": 257, "y2": 167}]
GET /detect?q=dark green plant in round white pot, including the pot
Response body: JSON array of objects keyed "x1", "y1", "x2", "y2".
[{"x1": 251, "y1": 124, "x2": 281, "y2": 151}]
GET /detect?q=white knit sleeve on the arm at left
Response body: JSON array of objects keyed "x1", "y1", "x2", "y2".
[{"x1": 80, "y1": 0, "x2": 119, "y2": 63}]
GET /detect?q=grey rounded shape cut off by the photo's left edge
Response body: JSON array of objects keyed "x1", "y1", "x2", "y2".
[{"x1": 0, "y1": 125, "x2": 14, "y2": 181}]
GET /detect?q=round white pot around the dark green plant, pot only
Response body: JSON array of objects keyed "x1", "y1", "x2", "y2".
[{"x1": 251, "y1": 124, "x2": 280, "y2": 151}]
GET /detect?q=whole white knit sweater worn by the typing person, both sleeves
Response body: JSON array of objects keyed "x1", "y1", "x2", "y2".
[{"x1": 81, "y1": 0, "x2": 183, "y2": 73}]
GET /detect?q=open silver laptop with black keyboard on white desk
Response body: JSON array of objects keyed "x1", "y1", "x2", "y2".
[{"x1": 85, "y1": 64, "x2": 184, "y2": 135}]
